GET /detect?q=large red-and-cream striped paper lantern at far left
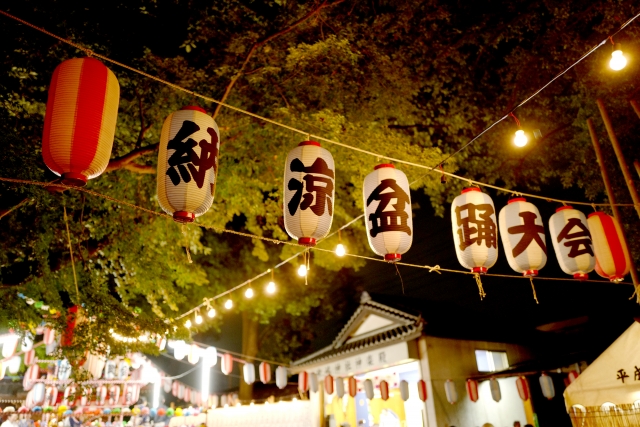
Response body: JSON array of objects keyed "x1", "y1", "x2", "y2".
[{"x1": 42, "y1": 58, "x2": 120, "y2": 187}]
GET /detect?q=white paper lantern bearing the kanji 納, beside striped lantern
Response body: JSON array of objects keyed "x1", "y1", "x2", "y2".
[{"x1": 157, "y1": 106, "x2": 220, "y2": 222}]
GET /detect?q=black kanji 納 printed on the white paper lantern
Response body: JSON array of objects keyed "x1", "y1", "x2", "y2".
[{"x1": 167, "y1": 120, "x2": 218, "y2": 188}]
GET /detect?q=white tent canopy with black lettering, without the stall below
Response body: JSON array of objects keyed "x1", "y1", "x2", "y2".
[{"x1": 564, "y1": 322, "x2": 640, "y2": 411}]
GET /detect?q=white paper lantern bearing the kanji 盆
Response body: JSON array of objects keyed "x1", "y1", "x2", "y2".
[{"x1": 362, "y1": 164, "x2": 413, "y2": 262}]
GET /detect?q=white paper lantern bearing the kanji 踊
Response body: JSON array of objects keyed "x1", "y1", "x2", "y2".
[{"x1": 451, "y1": 187, "x2": 498, "y2": 274}]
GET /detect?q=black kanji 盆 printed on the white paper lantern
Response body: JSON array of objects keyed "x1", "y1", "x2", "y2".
[{"x1": 367, "y1": 178, "x2": 411, "y2": 237}]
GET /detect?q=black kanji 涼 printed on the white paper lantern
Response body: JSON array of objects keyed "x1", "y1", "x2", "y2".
[{"x1": 287, "y1": 157, "x2": 335, "y2": 216}]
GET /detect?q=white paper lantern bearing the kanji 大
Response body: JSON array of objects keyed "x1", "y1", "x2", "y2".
[{"x1": 498, "y1": 197, "x2": 547, "y2": 277}]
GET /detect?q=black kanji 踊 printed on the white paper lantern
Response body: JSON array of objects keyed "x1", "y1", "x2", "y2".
[{"x1": 456, "y1": 203, "x2": 498, "y2": 251}]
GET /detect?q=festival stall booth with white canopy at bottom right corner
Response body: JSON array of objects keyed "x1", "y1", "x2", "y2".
[{"x1": 564, "y1": 322, "x2": 640, "y2": 427}]
